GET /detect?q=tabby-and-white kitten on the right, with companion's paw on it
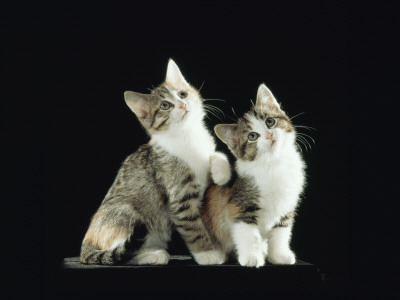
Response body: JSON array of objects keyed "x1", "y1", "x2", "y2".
[{"x1": 202, "y1": 84, "x2": 305, "y2": 267}]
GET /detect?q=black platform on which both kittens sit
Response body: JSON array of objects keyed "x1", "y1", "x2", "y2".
[{"x1": 49, "y1": 256, "x2": 326, "y2": 299}]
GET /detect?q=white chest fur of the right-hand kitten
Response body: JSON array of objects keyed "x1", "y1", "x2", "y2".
[{"x1": 236, "y1": 151, "x2": 304, "y2": 233}]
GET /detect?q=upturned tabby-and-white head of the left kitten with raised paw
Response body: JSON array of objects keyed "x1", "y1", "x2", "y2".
[{"x1": 124, "y1": 59, "x2": 205, "y2": 134}]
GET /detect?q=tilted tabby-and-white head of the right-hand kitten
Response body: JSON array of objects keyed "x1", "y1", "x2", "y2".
[{"x1": 214, "y1": 84, "x2": 295, "y2": 161}]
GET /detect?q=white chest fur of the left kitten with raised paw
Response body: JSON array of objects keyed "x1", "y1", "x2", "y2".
[{"x1": 151, "y1": 126, "x2": 215, "y2": 191}]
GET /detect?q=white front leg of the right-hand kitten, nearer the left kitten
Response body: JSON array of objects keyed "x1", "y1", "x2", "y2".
[{"x1": 232, "y1": 221, "x2": 265, "y2": 268}]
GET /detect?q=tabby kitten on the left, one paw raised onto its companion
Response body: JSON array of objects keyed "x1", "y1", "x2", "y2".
[{"x1": 80, "y1": 60, "x2": 230, "y2": 264}]
